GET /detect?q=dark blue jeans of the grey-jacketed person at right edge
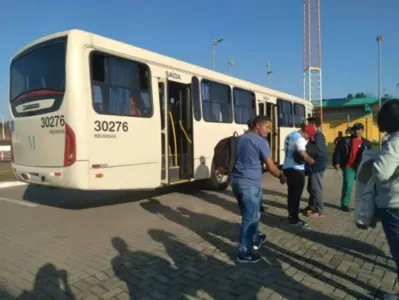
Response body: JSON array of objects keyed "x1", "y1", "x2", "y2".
[{"x1": 378, "y1": 208, "x2": 399, "y2": 280}]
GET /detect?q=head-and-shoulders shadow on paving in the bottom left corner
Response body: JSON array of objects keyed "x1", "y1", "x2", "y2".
[{"x1": 17, "y1": 263, "x2": 76, "y2": 300}]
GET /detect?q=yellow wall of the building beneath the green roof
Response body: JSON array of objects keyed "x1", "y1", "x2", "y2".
[{"x1": 322, "y1": 115, "x2": 379, "y2": 143}]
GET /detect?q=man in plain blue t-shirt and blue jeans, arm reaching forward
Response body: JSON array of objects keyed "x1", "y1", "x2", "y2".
[{"x1": 231, "y1": 116, "x2": 286, "y2": 263}]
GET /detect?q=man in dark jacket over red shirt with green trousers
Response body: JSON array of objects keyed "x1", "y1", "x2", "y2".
[{"x1": 333, "y1": 123, "x2": 371, "y2": 211}]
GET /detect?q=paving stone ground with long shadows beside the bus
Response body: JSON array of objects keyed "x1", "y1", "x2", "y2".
[{"x1": 0, "y1": 170, "x2": 396, "y2": 300}]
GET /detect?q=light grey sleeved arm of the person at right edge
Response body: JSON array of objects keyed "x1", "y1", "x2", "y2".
[{"x1": 373, "y1": 141, "x2": 399, "y2": 182}]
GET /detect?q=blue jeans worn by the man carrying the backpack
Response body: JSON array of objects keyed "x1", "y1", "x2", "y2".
[{"x1": 232, "y1": 184, "x2": 262, "y2": 254}]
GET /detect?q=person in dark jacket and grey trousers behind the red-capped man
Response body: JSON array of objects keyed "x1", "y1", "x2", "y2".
[{"x1": 305, "y1": 117, "x2": 327, "y2": 218}]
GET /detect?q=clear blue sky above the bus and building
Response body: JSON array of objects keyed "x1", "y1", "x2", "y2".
[{"x1": 0, "y1": 0, "x2": 399, "y2": 117}]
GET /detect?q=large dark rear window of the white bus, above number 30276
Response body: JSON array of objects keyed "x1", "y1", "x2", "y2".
[{"x1": 10, "y1": 38, "x2": 66, "y2": 102}]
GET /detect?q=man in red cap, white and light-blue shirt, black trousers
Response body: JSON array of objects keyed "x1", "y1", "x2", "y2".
[{"x1": 283, "y1": 125, "x2": 316, "y2": 226}]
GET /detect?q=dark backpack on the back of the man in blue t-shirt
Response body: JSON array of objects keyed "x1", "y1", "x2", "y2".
[{"x1": 213, "y1": 131, "x2": 238, "y2": 175}]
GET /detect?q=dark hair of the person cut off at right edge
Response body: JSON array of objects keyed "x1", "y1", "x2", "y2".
[{"x1": 377, "y1": 99, "x2": 399, "y2": 134}]
